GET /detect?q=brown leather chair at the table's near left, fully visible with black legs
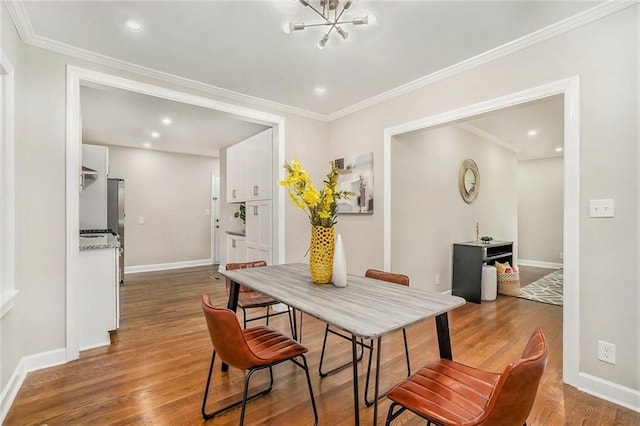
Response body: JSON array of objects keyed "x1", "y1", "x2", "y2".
[{"x1": 202, "y1": 294, "x2": 318, "y2": 425}]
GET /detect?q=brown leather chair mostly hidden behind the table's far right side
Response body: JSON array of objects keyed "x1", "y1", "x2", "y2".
[{"x1": 318, "y1": 269, "x2": 411, "y2": 406}]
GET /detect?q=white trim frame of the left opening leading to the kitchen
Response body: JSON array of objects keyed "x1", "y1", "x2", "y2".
[{"x1": 65, "y1": 65, "x2": 285, "y2": 361}]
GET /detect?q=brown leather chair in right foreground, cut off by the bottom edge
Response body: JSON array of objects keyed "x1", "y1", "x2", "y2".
[{"x1": 386, "y1": 329, "x2": 549, "y2": 426}]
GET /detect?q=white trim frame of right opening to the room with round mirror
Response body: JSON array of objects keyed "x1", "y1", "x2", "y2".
[{"x1": 383, "y1": 76, "x2": 582, "y2": 387}]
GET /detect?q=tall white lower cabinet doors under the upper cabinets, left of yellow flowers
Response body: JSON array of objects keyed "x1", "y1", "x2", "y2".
[{"x1": 246, "y1": 200, "x2": 271, "y2": 264}]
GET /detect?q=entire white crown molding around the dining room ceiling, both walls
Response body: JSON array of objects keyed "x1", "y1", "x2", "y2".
[{"x1": 4, "y1": 0, "x2": 639, "y2": 122}]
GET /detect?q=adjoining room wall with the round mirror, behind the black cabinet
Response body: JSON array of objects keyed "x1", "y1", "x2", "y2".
[{"x1": 391, "y1": 126, "x2": 517, "y2": 291}]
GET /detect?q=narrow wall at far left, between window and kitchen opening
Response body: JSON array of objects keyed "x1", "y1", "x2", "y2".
[{"x1": 0, "y1": 2, "x2": 65, "y2": 390}]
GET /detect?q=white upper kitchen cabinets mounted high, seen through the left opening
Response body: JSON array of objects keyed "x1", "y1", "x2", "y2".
[{"x1": 227, "y1": 129, "x2": 273, "y2": 203}]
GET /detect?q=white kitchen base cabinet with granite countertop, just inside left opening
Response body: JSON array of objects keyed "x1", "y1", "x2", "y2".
[{"x1": 78, "y1": 232, "x2": 120, "y2": 350}]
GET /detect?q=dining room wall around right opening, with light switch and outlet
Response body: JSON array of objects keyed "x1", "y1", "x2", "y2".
[{"x1": 329, "y1": 5, "x2": 640, "y2": 392}]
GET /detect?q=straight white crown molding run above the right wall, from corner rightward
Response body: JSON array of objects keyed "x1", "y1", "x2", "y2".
[{"x1": 327, "y1": 0, "x2": 638, "y2": 121}]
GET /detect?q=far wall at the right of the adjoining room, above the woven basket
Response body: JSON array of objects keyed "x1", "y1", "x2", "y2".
[{"x1": 518, "y1": 157, "x2": 564, "y2": 263}]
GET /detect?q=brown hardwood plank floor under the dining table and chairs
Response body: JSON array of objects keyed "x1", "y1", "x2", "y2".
[{"x1": 4, "y1": 267, "x2": 640, "y2": 425}]
